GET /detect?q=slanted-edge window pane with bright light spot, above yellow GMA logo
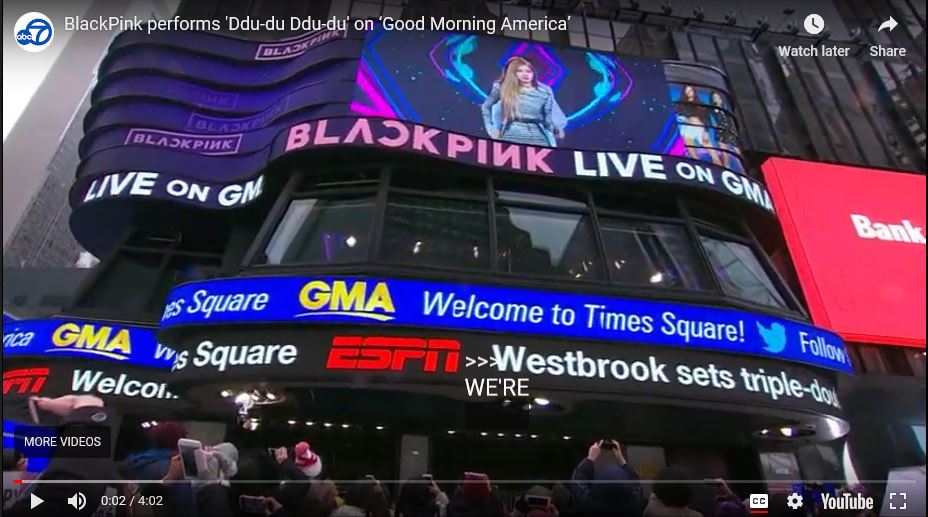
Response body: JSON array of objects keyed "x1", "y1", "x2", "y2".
[{"x1": 265, "y1": 195, "x2": 374, "y2": 264}]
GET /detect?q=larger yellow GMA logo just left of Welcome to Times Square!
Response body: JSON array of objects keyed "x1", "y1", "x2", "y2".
[{"x1": 297, "y1": 280, "x2": 396, "y2": 321}]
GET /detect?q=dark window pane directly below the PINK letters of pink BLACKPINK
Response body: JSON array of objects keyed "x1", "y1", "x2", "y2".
[{"x1": 380, "y1": 195, "x2": 490, "y2": 269}]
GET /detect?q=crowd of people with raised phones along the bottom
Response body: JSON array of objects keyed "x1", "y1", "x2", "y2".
[{"x1": 3, "y1": 395, "x2": 876, "y2": 517}]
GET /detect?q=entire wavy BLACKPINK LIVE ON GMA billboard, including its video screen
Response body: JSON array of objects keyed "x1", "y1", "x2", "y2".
[{"x1": 71, "y1": 28, "x2": 773, "y2": 252}]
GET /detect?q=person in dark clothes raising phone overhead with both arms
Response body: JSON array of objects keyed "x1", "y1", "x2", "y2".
[{"x1": 572, "y1": 438, "x2": 644, "y2": 515}]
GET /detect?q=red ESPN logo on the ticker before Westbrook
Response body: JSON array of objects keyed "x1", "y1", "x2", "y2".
[{"x1": 325, "y1": 336, "x2": 461, "y2": 373}]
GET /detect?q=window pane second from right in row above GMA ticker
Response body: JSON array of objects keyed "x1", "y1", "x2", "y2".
[{"x1": 600, "y1": 218, "x2": 703, "y2": 289}]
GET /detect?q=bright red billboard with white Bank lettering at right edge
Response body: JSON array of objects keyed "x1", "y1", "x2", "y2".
[{"x1": 762, "y1": 158, "x2": 925, "y2": 348}]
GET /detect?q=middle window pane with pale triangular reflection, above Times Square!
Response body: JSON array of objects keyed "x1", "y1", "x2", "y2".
[{"x1": 496, "y1": 206, "x2": 603, "y2": 280}]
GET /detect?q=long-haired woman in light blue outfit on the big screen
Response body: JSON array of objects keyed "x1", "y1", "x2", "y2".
[{"x1": 481, "y1": 56, "x2": 567, "y2": 147}]
